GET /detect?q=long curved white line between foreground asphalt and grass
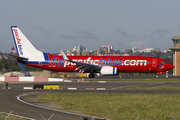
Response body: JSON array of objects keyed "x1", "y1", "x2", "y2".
[{"x1": 16, "y1": 92, "x2": 108, "y2": 120}]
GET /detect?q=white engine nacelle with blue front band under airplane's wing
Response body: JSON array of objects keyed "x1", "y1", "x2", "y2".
[{"x1": 100, "y1": 66, "x2": 117, "y2": 75}]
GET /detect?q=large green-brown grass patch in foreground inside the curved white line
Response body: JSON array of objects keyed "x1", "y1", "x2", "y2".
[{"x1": 25, "y1": 93, "x2": 180, "y2": 120}]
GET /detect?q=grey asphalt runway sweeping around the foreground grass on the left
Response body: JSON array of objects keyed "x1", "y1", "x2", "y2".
[{"x1": 0, "y1": 80, "x2": 180, "y2": 120}]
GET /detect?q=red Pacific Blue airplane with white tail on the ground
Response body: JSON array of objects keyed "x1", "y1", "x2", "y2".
[{"x1": 11, "y1": 26, "x2": 174, "y2": 78}]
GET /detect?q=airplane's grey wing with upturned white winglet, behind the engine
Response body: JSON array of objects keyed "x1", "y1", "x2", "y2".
[{"x1": 61, "y1": 50, "x2": 102, "y2": 72}]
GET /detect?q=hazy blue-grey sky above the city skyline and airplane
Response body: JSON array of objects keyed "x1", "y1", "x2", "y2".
[{"x1": 0, "y1": 0, "x2": 180, "y2": 53}]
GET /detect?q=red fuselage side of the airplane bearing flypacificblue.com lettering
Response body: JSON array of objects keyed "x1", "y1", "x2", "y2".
[{"x1": 25, "y1": 54, "x2": 165, "y2": 72}]
